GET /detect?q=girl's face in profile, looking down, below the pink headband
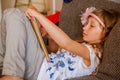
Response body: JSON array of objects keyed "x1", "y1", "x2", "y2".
[{"x1": 83, "y1": 17, "x2": 104, "y2": 43}]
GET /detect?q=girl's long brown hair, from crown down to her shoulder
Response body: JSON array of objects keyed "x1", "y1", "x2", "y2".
[{"x1": 92, "y1": 9, "x2": 119, "y2": 58}]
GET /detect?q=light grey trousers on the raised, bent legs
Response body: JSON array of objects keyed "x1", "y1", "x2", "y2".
[{"x1": 0, "y1": 8, "x2": 44, "y2": 80}]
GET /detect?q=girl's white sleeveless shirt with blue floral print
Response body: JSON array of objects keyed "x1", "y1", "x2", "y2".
[{"x1": 37, "y1": 44, "x2": 99, "y2": 80}]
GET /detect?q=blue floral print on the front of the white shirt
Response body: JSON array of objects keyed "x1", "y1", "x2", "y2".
[{"x1": 46, "y1": 53, "x2": 76, "y2": 78}]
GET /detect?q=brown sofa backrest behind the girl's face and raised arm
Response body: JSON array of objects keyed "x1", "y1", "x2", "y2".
[{"x1": 59, "y1": 0, "x2": 120, "y2": 39}]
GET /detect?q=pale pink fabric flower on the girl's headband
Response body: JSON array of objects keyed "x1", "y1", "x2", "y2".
[{"x1": 81, "y1": 7, "x2": 96, "y2": 25}]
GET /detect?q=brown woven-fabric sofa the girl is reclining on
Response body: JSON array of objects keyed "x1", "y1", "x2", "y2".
[{"x1": 59, "y1": 0, "x2": 120, "y2": 80}]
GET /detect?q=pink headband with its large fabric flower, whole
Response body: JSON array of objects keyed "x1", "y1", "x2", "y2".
[{"x1": 81, "y1": 7, "x2": 105, "y2": 27}]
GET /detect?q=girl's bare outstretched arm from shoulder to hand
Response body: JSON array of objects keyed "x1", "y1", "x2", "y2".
[{"x1": 26, "y1": 8, "x2": 90, "y2": 61}]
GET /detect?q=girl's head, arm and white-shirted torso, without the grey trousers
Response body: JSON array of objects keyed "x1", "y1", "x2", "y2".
[{"x1": 26, "y1": 7, "x2": 117, "y2": 80}]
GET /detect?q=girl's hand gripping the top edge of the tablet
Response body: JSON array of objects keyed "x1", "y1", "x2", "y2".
[{"x1": 25, "y1": 6, "x2": 40, "y2": 19}]
